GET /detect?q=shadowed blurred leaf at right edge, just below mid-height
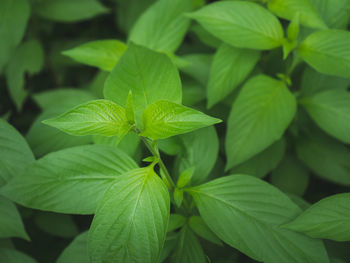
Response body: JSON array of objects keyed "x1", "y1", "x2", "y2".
[{"x1": 296, "y1": 132, "x2": 350, "y2": 185}]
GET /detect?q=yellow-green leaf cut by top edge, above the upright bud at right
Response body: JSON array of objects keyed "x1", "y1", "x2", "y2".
[{"x1": 267, "y1": 0, "x2": 327, "y2": 29}]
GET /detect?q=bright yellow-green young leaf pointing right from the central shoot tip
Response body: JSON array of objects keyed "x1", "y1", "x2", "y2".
[{"x1": 140, "y1": 100, "x2": 221, "y2": 140}]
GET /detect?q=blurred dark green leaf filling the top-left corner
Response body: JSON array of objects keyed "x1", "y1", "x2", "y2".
[{"x1": 0, "y1": 0, "x2": 30, "y2": 73}]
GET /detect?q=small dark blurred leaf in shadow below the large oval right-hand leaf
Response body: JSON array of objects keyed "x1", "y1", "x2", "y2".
[{"x1": 270, "y1": 155, "x2": 309, "y2": 196}]
